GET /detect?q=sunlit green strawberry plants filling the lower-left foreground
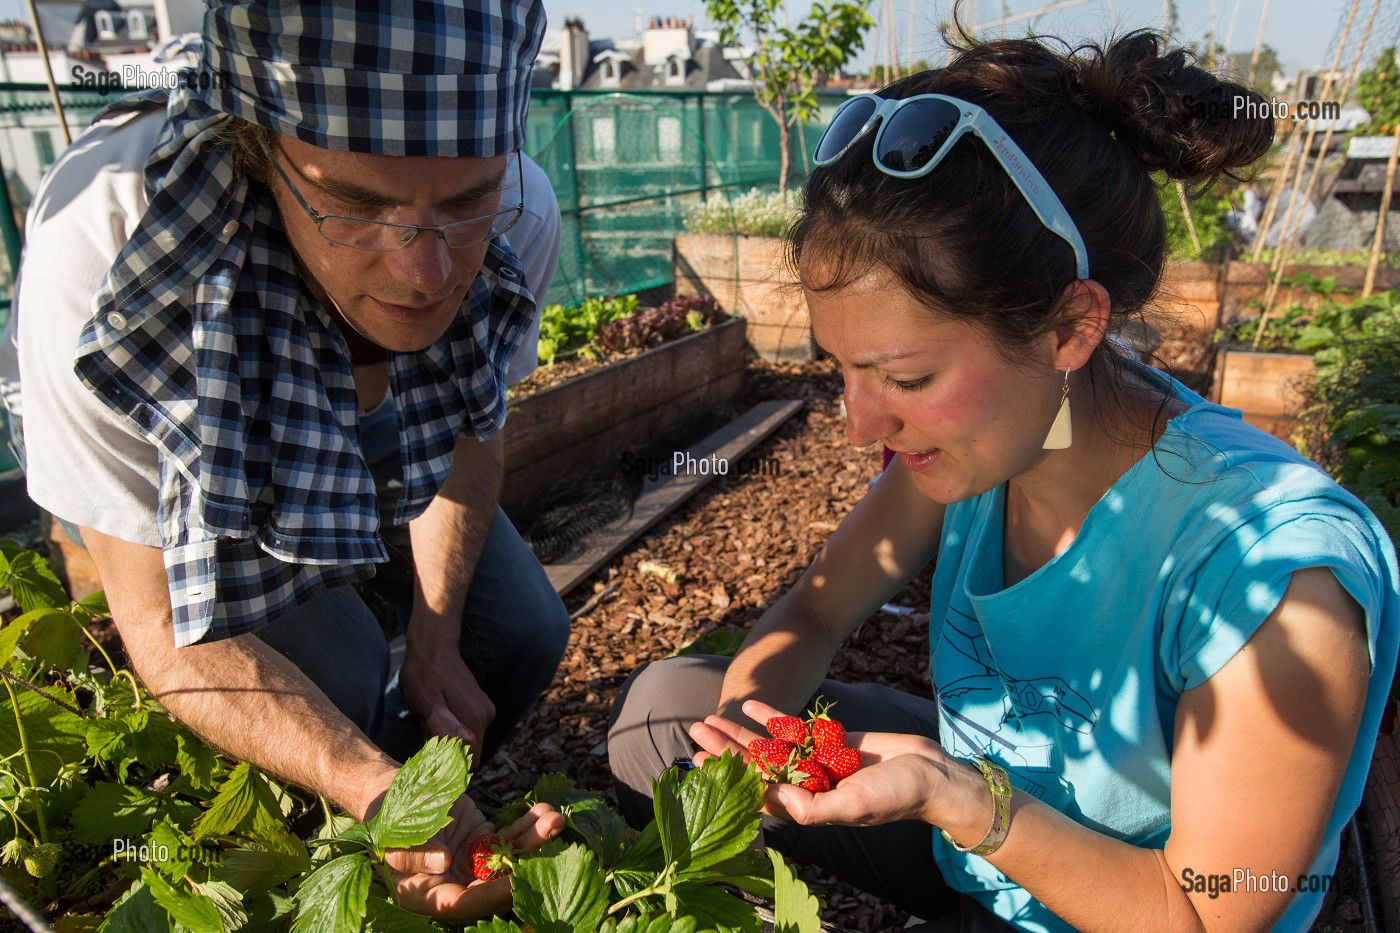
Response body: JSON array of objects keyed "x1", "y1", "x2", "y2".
[{"x1": 0, "y1": 541, "x2": 819, "y2": 933}]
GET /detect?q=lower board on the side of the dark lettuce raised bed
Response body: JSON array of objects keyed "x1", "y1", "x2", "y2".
[{"x1": 501, "y1": 368, "x2": 746, "y2": 506}]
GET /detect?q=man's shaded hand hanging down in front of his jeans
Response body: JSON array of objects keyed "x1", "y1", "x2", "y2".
[{"x1": 399, "y1": 644, "x2": 496, "y2": 761}]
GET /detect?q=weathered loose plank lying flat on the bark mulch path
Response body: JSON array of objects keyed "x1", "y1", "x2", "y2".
[{"x1": 545, "y1": 399, "x2": 802, "y2": 595}]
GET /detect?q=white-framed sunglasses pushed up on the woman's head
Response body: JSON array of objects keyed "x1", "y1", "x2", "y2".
[{"x1": 813, "y1": 94, "x2": 1089, "y2": 279}]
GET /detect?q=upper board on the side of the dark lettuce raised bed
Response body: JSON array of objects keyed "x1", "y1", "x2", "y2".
[{"x1": 505, "y1": 321, "x2": 745, "y2": 471}]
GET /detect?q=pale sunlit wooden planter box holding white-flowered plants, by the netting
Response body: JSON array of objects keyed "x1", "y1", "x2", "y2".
[{"x1": 672, "y1": 234, "x2": 815, "y2": 363}]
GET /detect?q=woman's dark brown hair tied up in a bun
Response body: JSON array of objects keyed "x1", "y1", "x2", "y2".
[{"x1": 788, "y1": 31, "x2": 1273, "y2": 375}]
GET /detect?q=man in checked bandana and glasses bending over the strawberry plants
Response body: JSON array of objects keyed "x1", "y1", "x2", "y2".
[{"x1": 5, "y1": 0, "x2": 568, "y2": 920}]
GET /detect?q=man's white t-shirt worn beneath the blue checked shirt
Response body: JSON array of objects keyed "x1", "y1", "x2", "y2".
[{"x1": 0, "y1": 111, "x2": 560, "y2": 546}]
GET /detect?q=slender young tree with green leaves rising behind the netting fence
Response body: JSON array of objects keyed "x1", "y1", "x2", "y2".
[{"x1": 706, "y1": 0, "x2": 875, "y2": 192}]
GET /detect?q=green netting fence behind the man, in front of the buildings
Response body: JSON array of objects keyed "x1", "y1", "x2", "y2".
[{"x1": 0, "y1": 84, "x2": 841, "y2": 316}]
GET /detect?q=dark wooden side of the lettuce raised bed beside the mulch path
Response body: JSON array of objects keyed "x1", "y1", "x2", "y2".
[{"x1": 501, "y1": 321, "x2": 745, "y2": 504}]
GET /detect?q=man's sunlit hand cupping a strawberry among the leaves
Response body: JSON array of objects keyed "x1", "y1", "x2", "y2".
[{"x1": 384, "y1": 796, "x2": 564, "y2": 923}]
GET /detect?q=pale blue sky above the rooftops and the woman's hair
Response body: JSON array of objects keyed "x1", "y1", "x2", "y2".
[{"x1": 545, "y1": 0, "x2": 1400, "y2": 76}]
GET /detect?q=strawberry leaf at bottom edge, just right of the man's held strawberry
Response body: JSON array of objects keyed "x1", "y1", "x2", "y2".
[{"x1": 512, "y1": 841, "x2": 608, "y2": 933}]
